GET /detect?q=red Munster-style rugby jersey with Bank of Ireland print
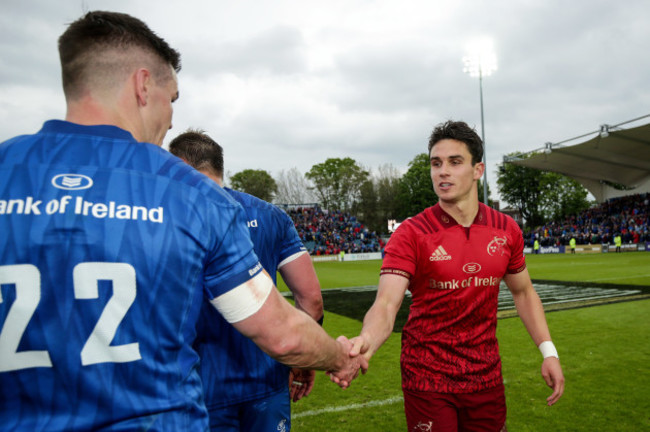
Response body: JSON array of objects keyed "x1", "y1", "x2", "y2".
[{"x1": 381, "y1": 203, "x2": 526, "y2": 393}]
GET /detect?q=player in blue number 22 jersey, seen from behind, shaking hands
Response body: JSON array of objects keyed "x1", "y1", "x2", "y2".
[{"x1": 0, "y1": 12, "x2": 359, "y2": 432}]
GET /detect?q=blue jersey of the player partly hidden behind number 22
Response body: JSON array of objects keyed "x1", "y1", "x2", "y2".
[{"x1": 196, "y1": 188, "x2": 306, "y2": 410}]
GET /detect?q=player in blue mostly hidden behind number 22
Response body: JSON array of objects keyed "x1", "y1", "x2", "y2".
[{"x1": 169, "y1": 130, "x2": 323, "y2": 432}]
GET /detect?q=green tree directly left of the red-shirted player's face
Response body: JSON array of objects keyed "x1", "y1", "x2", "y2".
[{"x1": 396, "y1": 153, "x2": 438, "y2": 220}]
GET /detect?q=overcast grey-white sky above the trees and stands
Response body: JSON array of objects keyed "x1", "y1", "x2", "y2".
[{"x1": 0, "y1": 0, "x2": 650, "y2": 204}]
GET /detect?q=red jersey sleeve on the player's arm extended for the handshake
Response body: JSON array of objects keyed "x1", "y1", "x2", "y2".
[{"x1": 380, "y1": 221, "x2": 417, "y2": 279}]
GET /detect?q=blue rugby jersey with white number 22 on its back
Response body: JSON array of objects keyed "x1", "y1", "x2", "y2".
[{"x1": 0, "y1": 121, "x2": 260, "y2": 431}]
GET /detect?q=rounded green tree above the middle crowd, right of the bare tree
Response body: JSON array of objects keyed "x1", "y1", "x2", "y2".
[{"x1": 305, "y1": 158, "x2": 369, "y2": 211}]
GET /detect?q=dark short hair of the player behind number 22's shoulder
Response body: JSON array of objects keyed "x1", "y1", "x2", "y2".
[{"x1": 169, "y1": 129, "x2": 223, "y2": 177}]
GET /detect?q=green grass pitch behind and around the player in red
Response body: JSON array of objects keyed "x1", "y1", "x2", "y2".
[{"x1": 279, "y1": 252, "x2": 650, "y2": 432}]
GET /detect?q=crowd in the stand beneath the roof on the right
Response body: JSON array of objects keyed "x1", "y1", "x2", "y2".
[{"x1": 524, "y1": 193, "x2": 650, "y2": 246}]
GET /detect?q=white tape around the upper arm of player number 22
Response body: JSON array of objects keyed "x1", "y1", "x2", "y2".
[{"x1": 210, "y1": 272, "x2": 273, "y2": 323}]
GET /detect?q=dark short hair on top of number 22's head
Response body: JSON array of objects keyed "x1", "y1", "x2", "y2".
[{"x1": 59, "y1": 11, "x2": 181, "y2": 94}]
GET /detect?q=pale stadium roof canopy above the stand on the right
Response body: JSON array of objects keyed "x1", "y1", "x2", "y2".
[{"x1": 504, "y1": 114, "x2": 650, "y2": 202}]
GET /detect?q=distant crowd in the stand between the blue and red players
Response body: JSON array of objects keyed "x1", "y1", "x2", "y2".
[{"x1": 286, "y1": 206, "x2": 384, "y2": 255}]
